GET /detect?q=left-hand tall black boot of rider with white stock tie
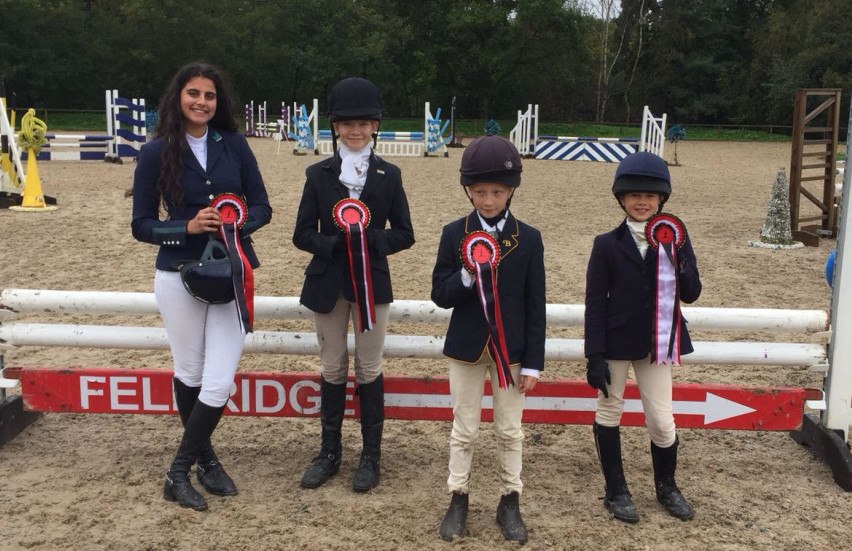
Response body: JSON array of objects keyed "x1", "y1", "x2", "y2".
[{"x1": 302, "y1": 379, "x2": 346, "y2": 488}]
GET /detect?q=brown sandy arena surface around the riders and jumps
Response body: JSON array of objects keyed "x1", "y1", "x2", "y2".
[{"x1": 0, "y1": 139, "x2": 852, "y2": 551}]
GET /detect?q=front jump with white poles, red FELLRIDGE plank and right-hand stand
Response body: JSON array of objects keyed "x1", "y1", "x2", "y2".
[{"x1": 0, "y1": 260, "x2": 852, "y2": 490}]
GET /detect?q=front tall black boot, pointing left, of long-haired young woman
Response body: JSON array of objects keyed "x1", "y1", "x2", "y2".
[{"x1": 163, "y1": 401, "x2": 225, "y2": 511}]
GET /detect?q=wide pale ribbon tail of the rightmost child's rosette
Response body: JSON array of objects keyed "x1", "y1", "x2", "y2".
[{"x1": 654, "y1": 243, "x2": 680, "y2": 365}]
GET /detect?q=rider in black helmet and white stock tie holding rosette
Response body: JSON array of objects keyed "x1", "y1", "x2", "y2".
[{"x1": 293, "y1": 78, "x2": 414, "y2": 492}]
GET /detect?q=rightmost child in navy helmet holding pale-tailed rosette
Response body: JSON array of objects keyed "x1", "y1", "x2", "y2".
[{"x1": 585, "y1": 152, "x2": 701, "y2": 523}]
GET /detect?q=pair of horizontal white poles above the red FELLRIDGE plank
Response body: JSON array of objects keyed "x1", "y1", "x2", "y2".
[{"x1": 0, "y1": 289, "x2": 828, "y2": 366}]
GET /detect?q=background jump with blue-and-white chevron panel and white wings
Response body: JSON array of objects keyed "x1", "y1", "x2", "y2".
[{"x1": 509, "y1": 104, "x2": 666, "y2": 163}]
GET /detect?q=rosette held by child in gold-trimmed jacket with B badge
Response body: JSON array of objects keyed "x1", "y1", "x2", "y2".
[{"x1": 459, "y1": 231, "x2": 515, "y2": 390}]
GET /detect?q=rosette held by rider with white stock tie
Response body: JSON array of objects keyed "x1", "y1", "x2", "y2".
[{"x1": 332, "y1": 198, "x2": 376, "y2": 333}]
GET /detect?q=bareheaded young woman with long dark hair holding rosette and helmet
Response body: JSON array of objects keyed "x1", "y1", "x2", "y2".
[{"x1": 131, "y1": 63, "x2": 272, "y2": 511}]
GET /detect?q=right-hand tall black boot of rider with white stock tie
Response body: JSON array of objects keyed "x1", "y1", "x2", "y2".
[{"x1": 352, "y1": 375, "x2": 385, "y2": 492}]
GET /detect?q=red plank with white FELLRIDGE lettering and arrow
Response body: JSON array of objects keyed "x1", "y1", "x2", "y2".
[{"x1": 7, "y1": 368, "x2": 821, "y2": 430}]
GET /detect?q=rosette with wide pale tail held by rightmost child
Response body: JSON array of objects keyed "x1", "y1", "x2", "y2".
[{"x1": 645, "y1": 213, "x2": 686, "y2": 365}]
